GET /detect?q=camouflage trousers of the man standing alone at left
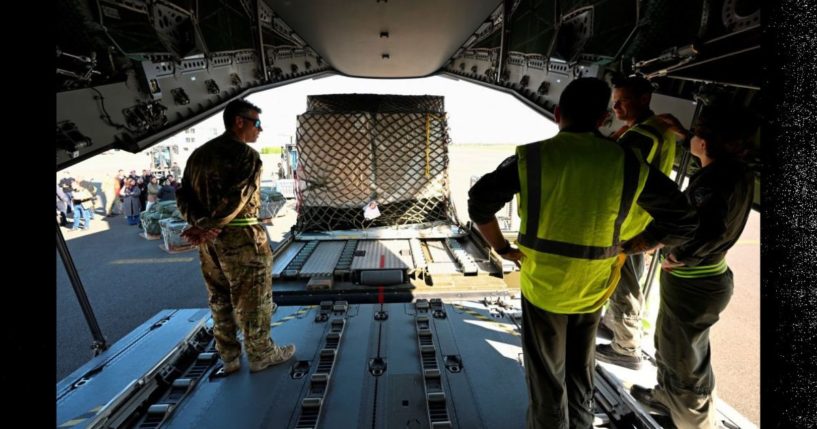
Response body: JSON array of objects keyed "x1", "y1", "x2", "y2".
[{"x1": 199, "y1": 225, "x2": 275, "y2": 362}]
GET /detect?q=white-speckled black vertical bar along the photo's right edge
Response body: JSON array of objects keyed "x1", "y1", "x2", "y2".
[{"x1": 758, "y1": 0, "x2": 817, "y2": 428}]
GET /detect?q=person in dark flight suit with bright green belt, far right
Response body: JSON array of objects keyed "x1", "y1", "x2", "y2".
[{"x1": 631, "y1": 105, "x2": 756, "y2": 429}]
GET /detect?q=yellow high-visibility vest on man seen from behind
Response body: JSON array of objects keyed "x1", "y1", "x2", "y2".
[{"x1": 516, "y1": 132, "x2": 648, "y2": 314}]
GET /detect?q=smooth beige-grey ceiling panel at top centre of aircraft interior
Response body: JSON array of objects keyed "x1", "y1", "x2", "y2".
[{"x1": 268, "y1": 0, "x2": 499, "y2": 78}]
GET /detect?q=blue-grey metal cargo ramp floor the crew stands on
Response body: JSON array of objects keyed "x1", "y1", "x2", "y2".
[{"x1": 56, "y1": 298, "x2": 753, "y2": 429}]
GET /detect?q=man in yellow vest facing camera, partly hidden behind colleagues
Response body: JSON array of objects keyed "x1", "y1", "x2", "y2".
[{"x1": 596, "y1": 77, "x2": 675, "y2": 369}]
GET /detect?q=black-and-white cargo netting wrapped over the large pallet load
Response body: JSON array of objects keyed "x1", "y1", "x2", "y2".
[{"x1": 295, "y1": 94, "x2": 456, "y2": 231}]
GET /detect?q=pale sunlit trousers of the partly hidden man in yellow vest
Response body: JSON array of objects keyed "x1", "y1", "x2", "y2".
[{"x1": 602, "y1": 253, "x2": 644, "y2": 357}]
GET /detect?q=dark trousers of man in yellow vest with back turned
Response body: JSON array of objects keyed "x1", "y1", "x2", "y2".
[{"x1": 522, "y1": 297, "x2": 601, "y2": 429}]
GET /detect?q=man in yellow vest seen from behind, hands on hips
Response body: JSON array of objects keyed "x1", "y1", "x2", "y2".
[{"x1": 468, "y1": 78, "x2": 698, "y2": 428}]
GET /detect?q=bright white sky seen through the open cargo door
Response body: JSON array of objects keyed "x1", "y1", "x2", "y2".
[{"x1": 194, "y1": 76, "x2": 558, "y2": 146}]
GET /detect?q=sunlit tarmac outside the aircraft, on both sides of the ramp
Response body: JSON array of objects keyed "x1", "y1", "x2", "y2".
[{"x1": 55, "y1": 146, "x2": 760, "y2": 424}]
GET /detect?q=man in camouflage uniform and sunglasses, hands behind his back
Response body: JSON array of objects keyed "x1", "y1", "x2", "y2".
[{"x1": 176, "y1": 100, "x2": 295, "y2": 374}]
